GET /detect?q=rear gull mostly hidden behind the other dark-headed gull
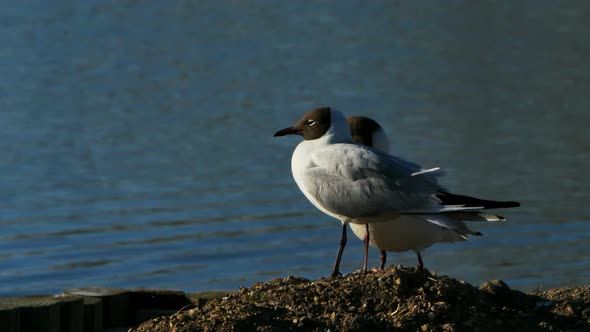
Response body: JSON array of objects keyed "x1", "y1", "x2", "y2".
[{"x1": 348, "y1": 116, "x2": 520, "y2": 270}]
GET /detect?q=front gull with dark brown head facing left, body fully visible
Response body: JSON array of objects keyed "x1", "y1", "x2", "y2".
[{"x1": 274, "y1": 107, "x2": 518, "y2": 276}]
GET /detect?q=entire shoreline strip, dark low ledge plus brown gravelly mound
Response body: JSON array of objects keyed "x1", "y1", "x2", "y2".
[{"x1": 0, "y1": 266, "x2": 590, "y2": 332}]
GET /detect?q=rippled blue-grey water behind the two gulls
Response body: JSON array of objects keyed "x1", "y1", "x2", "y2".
[{"x1": 0, "y1": 0, "x2": 590, "y2": 296}]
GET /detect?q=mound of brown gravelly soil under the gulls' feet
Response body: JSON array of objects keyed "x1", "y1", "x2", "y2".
[{"x1": 131, "y1": 266, "x2": 590, "y2": 332}]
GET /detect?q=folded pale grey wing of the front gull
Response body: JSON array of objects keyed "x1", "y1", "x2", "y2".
[{"x1": 303, "y1": 144, "x2": 443, "y2": 218}]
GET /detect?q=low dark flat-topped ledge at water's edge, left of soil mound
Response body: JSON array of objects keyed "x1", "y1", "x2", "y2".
[{"x1": 0, "y1": 286, "x2": 237, "y2": 332}]
